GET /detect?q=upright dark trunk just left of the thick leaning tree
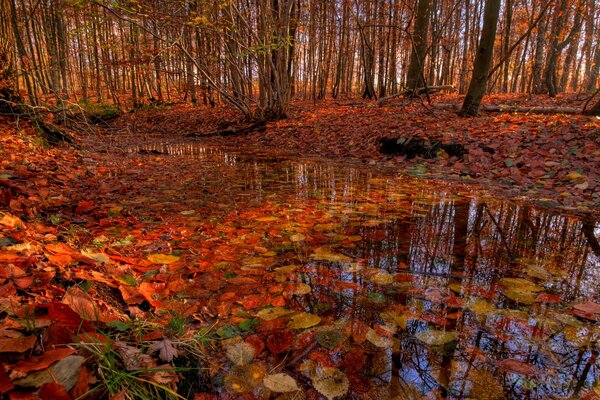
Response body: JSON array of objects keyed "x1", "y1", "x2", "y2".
[{"x1": 406, "y1": 0, "x2": 431, "y2": 91}]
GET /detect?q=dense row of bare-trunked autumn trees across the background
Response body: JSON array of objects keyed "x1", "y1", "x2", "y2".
[{"x1": 0, "y1": 0, "x2": 600, "y2": 119}]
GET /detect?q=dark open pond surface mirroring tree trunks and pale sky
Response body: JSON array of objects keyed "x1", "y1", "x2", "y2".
[{"x1": 124, "y1": 144, "x2": 600, "y2": 398}]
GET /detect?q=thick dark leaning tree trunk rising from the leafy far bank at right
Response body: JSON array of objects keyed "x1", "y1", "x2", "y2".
[{"x1": 460, "y1": 0, "x2": 500, "y2": 116}]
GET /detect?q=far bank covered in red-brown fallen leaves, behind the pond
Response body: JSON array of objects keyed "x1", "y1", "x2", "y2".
[{"x1": 115, "y1": 95, "x2": 600, "y2": 216}]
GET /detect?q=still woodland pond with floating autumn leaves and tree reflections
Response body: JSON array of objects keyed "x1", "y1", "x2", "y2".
[{"x1": 107, "y1": 143, "x2": 600, "y2": 399}]
